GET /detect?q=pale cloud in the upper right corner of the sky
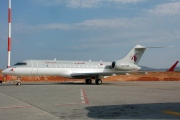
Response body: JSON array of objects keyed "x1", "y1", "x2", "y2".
[{"x1": 148, "y1": 2, "x2": 180, "y2": 15}]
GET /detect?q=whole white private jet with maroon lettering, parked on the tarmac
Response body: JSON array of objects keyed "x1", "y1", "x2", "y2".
[{"x1": 2, "y1": 45, "x2": 160, "y2": 85}]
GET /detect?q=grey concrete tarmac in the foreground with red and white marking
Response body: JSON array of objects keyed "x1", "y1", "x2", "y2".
[{"x1": 0, "y1": 81, "x2": 180, "y2": 120}]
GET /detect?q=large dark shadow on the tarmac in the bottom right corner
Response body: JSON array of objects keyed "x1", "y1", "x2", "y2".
[{"x1": 86, "y1": 103, "x2": 180, "y2": 119}]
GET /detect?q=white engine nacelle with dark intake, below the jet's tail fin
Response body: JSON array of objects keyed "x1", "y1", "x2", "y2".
[{"x1": 111, "y1": 61, "x2": 141, "y2": 71}]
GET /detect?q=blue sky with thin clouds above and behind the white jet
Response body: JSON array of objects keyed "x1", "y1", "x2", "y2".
[{"x1": 0, "y1": 0, "x2": 180, "y2": 69}]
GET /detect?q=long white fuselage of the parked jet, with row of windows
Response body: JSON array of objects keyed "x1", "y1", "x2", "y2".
[{"x1": 3, "y1": 60, "x2": 140, "y2": 78}]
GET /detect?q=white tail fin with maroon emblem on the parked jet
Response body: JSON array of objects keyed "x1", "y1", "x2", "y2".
[{"x1": 121, "y1": 45, "x2": 147, "y2": 64}]
